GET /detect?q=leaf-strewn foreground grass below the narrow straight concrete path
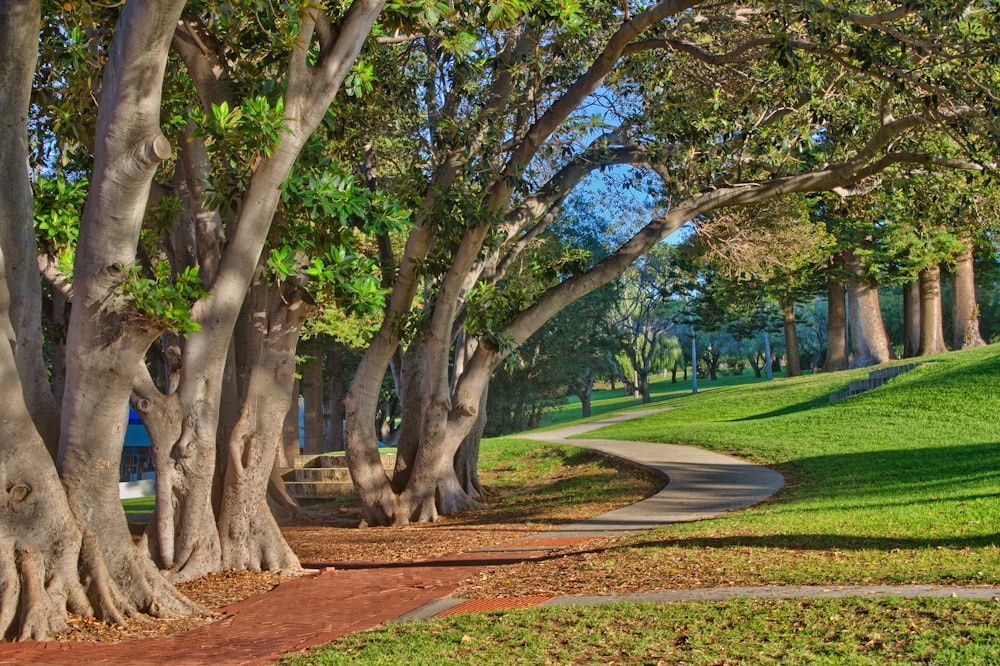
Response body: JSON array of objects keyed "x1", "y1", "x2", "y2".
[{"x1": 283, "y1": 599, "x2": 1000, "y2": 666}]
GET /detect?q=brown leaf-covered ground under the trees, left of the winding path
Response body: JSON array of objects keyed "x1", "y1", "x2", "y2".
[{"x1": 58, "y1": 445, "x2": 664, "y2": 641}]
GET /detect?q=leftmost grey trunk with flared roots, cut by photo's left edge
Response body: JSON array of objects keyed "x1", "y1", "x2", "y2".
[{"x1": 0, "y1": 0, "x2": 97, "y2": 640}]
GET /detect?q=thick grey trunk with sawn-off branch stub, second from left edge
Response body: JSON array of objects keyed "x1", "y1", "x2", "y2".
[{"x1": 58, "y1": 0, "x2": 200, "y2": 616}]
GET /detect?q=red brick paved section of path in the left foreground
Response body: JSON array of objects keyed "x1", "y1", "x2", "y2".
[{"x1": 0, "y1": 547, "x2": 551, "y2": 666}]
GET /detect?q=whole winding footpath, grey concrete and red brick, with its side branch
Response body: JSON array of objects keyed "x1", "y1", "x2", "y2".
[{"x1": 0, "y1": 411, "x2": 1000, "y2": 666}]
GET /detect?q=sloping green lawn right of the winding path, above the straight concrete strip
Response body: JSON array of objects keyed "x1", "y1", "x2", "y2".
[{"x1": 598, "y1": 346, "x2": 1000, "y2": 585}]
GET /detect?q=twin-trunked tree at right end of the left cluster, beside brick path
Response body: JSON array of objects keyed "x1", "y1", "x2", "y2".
[{"x1": 122, "y1": 0, "x2": 384, "y2": 582}]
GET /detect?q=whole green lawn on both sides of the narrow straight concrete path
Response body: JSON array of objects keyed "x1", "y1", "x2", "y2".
[{"x1": 280, "y1": 345, "x2": 1000, "y2": 664}]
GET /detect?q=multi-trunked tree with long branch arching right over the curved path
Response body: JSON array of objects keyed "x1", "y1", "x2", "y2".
[{"x1": 346, "y1": 2, "x2": 988, "y2": 524}]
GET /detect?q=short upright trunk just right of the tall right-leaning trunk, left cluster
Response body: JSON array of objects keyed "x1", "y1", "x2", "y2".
[{"x1": 218, "y1": 280, "x2": 310, "y2": 574}]
